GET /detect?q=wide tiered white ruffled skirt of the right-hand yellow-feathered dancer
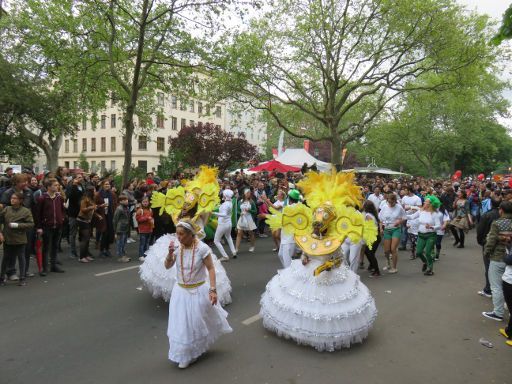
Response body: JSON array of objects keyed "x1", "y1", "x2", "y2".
[{"x1": 260, "y1": 258, "x2": 377, "y2": 351}]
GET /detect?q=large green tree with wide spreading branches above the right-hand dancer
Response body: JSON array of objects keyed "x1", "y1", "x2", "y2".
[{"x1": 217, "y1": 0, "x2": 496, "y2": 166}]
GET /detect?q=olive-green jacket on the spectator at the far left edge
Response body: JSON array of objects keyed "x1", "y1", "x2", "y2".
[{"x1": 0, "y1": 206, "x2": 34, "y2": 245}]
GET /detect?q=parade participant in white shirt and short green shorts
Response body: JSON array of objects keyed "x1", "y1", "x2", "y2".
[{"x1": 379, "y1": 193, "x2": 406, "y2": 273}]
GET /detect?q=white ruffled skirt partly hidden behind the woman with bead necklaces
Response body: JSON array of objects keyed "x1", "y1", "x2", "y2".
[{"x1": 139, "y1": 234, "x2": 231, "y2": 306}]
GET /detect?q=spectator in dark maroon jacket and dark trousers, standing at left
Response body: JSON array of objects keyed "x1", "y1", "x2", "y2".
[{"x1": 35, "y1": 178, "x2": 65, "y2": 276}]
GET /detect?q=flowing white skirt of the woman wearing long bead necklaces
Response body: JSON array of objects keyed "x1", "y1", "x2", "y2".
[{"x1": 167, "y1": 284, "x2": 232, "y2": 363}]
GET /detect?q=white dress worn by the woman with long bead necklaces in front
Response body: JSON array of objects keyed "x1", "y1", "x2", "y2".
[{"x1": 167, "y1": 240, "x2": 232, "y2": 363}]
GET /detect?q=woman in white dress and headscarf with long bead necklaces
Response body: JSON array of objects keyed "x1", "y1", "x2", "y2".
[{"x1": 164, "y1": 221, "x2": 232, "y2": 368}]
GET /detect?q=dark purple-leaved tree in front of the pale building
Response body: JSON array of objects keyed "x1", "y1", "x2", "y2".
[{"x1": 169, "y1": 124, "x2": 258, "y2": 171}]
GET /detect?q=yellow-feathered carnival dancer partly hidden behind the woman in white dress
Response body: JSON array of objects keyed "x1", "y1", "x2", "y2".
[{"x1": 139, "y1": 166, "x2": 231, "y2": 306}]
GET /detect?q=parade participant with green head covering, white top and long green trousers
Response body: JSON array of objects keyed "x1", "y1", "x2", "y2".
[{"x1": 416, "y1": 196, "x2": 442, "y2": 276}]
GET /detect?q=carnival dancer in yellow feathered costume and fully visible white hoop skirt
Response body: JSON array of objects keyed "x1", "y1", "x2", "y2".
[{"x1": 260, "y1": 172, "x2": 377, "y2": 351}]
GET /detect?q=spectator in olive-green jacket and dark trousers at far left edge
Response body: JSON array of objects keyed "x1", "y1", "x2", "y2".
[{"x1": 0, "y1": 192, "x2": 34, "y2": 286}]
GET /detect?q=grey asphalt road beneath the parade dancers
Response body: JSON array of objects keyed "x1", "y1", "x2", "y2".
[{"x1": 0, "y1": 233, "x2": 512, "y2": 384}]
